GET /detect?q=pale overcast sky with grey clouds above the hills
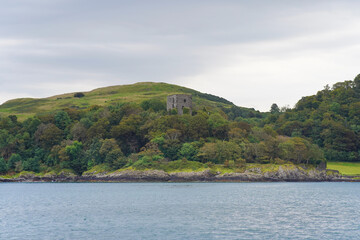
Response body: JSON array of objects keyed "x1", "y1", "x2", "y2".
[{"x1": 0, "y1": 0, "x2": 360, "y2": 111}]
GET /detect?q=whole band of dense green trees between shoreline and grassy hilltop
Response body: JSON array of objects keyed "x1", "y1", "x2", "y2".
[{"x1": 0, "y1": 75, "x2": 360, "y2": 174}]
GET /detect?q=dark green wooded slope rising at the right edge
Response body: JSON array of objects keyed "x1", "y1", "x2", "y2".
[{"x1": 265, "y1": 74, "x2": 360, "y2": 161}]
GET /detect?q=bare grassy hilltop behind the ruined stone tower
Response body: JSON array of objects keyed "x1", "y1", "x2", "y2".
[{"x1": 0, "y1": 82, "x2": 245, "y2": 119}]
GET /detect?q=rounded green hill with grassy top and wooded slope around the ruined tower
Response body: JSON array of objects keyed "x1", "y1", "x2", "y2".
[{"x1": 0, "y1": 80, "x2": 334, "y2": 176}]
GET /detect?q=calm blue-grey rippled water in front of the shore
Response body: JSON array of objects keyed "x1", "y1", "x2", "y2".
[{"x1": 0, "y1": 183, "x2": 360, "y2": 240}]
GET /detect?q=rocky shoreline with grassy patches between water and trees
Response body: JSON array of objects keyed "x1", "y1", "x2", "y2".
[{"x1": 0, "y1": 166, "x2": 360, "y2": 182}]
